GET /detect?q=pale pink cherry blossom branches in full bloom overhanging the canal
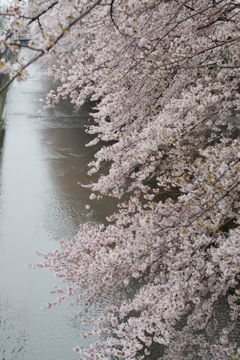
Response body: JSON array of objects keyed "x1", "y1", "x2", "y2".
[{"x1": 1, "y1": 0, "x2": 240, "y2": 360}]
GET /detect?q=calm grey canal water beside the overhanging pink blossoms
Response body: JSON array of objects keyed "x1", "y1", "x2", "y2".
[{"x1": 0, "y1": 59, "x2": 115, "y2": 360}]
